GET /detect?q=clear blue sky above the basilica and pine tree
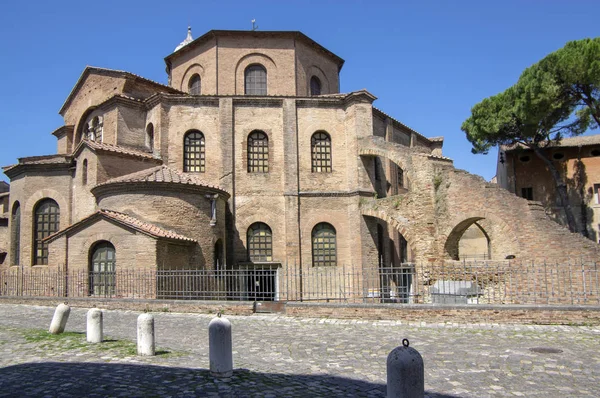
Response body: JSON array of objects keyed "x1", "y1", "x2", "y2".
[{"x1": 0, "y1": 0, "x2": 600, "y2": 180}]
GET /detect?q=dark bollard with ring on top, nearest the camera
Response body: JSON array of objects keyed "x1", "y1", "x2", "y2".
[{"x1": 387, "y1": 339, "x2": 425, "y2": 398}]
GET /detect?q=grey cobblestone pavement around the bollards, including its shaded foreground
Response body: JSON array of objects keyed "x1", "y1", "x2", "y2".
[{"x1": 0, "y1": 305, "x2": 600, "y2": 398}]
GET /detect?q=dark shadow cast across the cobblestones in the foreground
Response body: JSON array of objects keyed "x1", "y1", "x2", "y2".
[{"x1": 0, "y1": 362, "x2": 455, "y2": 398}]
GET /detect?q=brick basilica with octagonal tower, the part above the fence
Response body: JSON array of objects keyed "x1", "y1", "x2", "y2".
[{"x1": 0, "y1": 30, "x2": 599, "y2": 298}]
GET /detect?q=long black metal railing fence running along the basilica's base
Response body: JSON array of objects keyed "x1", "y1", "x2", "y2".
[{"x1": 0, "y1": 261, "x2": 600, "y2": 305}]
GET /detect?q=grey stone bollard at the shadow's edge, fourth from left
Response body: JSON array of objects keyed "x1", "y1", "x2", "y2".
[{"x1": 208, "y1": 313, "x2": 233, "y2": 377}]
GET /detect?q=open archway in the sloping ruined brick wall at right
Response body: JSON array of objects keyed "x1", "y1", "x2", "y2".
[{"x1": 444, "y1": 217, "x2": 492, "y2": 260}]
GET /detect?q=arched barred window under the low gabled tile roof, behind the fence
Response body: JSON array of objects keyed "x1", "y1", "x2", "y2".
[{"x1": 89, "y1": 241, "x2": 116, "y2": 296}]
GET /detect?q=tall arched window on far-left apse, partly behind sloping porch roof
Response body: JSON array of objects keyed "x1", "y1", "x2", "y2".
[{"x1": 33, "y1": 199, "x2": 60, "y2": 265}]
